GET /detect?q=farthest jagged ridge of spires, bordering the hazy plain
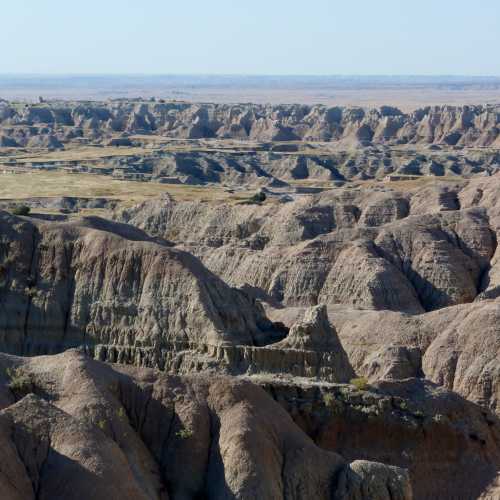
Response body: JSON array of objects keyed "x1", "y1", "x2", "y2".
[{"x1": 0, "y1": 102, "x2": 500, "y2": 147}]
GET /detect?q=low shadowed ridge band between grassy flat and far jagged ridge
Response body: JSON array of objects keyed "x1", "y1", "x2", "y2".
[{"x1": 135, "y1": 146, "x2": 500, "y2": 187}]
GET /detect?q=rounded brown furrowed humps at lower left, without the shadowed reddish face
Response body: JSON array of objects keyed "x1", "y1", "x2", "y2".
[{"x1": 0, "y1": 351, "x2": 412, "y2": 500}]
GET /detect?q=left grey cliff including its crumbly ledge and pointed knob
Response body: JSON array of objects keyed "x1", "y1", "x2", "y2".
[{"x1": 0, "y1": 212, "x2": 360, "y2": 382}]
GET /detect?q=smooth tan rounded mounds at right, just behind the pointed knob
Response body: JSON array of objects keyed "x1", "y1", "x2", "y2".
[{"x1": 322, "y1": 300, "x2": 500, "y2": 414}]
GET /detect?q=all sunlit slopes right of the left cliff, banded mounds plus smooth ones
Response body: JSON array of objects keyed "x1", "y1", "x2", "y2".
[{"x1": 117, "y1": 176, "x2": 500, "y2": 413}]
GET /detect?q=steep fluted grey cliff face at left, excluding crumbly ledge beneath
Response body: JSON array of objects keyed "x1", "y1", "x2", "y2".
[{"x1": 0, "y1": 212, "x2": 281, "y2": 355}]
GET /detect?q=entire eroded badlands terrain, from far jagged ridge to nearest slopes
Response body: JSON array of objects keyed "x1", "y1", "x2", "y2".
[{"x1": 0, "y1": 101, "x2": 500, "y2": 500}]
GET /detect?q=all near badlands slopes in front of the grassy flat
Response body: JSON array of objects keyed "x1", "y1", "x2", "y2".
[{"x1": 0, "y1": 124, "x2": 500, "y2": 500}]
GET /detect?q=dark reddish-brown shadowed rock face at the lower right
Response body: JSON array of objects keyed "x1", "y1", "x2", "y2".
[{"x1": 265, "y1": 379, "x2": 500, "y2": 500}]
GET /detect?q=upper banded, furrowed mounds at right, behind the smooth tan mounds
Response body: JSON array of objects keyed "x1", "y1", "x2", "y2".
[{"x1": 116, "y1": 176, "x2": 500, "y2": 314}]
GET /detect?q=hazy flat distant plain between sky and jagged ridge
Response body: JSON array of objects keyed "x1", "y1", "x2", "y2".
[{"x1": 0, "y1": 74, "x2": 500, "y2": 111}]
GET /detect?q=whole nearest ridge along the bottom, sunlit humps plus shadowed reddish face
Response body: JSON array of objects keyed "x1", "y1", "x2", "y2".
[{"x1": 0, "y1": 351, "x2": 500, "y2": 500}]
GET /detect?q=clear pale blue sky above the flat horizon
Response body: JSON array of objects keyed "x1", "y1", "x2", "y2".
[{"x1": 0, "y1": 0, "x2": 500, "y2": 76}]
